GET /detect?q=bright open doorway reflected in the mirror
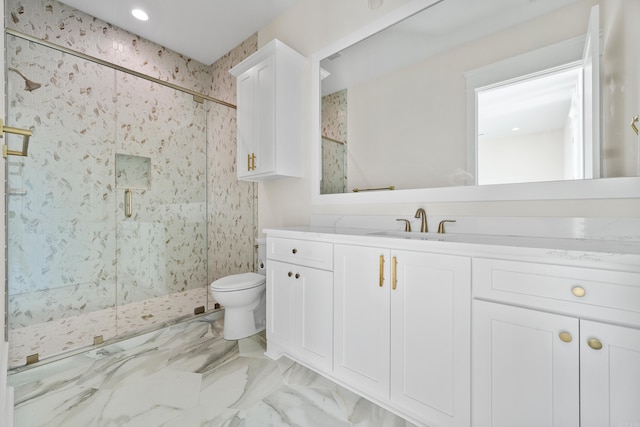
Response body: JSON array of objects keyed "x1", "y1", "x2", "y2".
[{"x1": 476, "y1": 67, "x2": 584, "y2": 185}]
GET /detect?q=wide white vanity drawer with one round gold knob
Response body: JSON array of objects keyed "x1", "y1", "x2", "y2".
[{"x1": 473, "y1": 258, "x2": 640, "y2": 313}]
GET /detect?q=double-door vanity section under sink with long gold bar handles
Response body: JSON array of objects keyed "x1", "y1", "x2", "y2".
[{"x1": 333, "y1": 244, "x2": 471, "y2": 426}]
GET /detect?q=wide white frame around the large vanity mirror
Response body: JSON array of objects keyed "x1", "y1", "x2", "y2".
[{"x1": 310, "y1": 0, "x2": 640, "y2": 205}]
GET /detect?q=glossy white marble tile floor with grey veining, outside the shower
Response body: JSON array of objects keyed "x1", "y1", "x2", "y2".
[{"x1": 9, "y1": 316, "x2": 420, "y2": 427}]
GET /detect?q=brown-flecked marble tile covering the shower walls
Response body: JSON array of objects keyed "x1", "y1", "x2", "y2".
[{"x1": 6, "y1": 0, "x2": 257, "y2": 366}]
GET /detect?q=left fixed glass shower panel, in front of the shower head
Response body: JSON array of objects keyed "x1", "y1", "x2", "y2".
[{"x1": 6, "y1": 36, "x2": 117, "y2": 359}]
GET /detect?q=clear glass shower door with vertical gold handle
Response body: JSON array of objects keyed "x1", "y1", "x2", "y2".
[{"x1": 116, "y1": 72, "x2": 207, "y2": 333}]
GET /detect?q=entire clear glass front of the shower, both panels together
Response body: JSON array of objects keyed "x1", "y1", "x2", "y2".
[{"x1": 6, "y1": 35, "x2": 208, "y2": 366}]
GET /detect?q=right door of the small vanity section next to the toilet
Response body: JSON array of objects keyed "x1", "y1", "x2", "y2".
[{"x1": 293, "y1": 267, "x2": 333, "y2": 372}]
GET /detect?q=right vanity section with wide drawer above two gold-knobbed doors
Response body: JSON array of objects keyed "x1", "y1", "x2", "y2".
[{"x1": 472, "y1": 258, "x2": 640, "y2": 427}]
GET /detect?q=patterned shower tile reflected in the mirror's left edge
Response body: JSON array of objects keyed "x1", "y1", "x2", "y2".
[{"x1": 321, "y1": 89, "x2": 347, "y2": 194}]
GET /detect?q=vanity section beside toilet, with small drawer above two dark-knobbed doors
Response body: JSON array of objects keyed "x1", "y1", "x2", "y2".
[{"x1": 267, "y1": 237, "x2": 333, "y2": 372}]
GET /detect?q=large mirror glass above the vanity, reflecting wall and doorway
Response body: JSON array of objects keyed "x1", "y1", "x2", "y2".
[{"x1": 320, "y1": 0, "x2": 640, "y2": 194}]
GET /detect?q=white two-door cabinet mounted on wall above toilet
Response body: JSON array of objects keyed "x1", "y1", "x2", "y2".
[{"x1": 229, "y1": 40, "x2": 304, "y2": 181}]
